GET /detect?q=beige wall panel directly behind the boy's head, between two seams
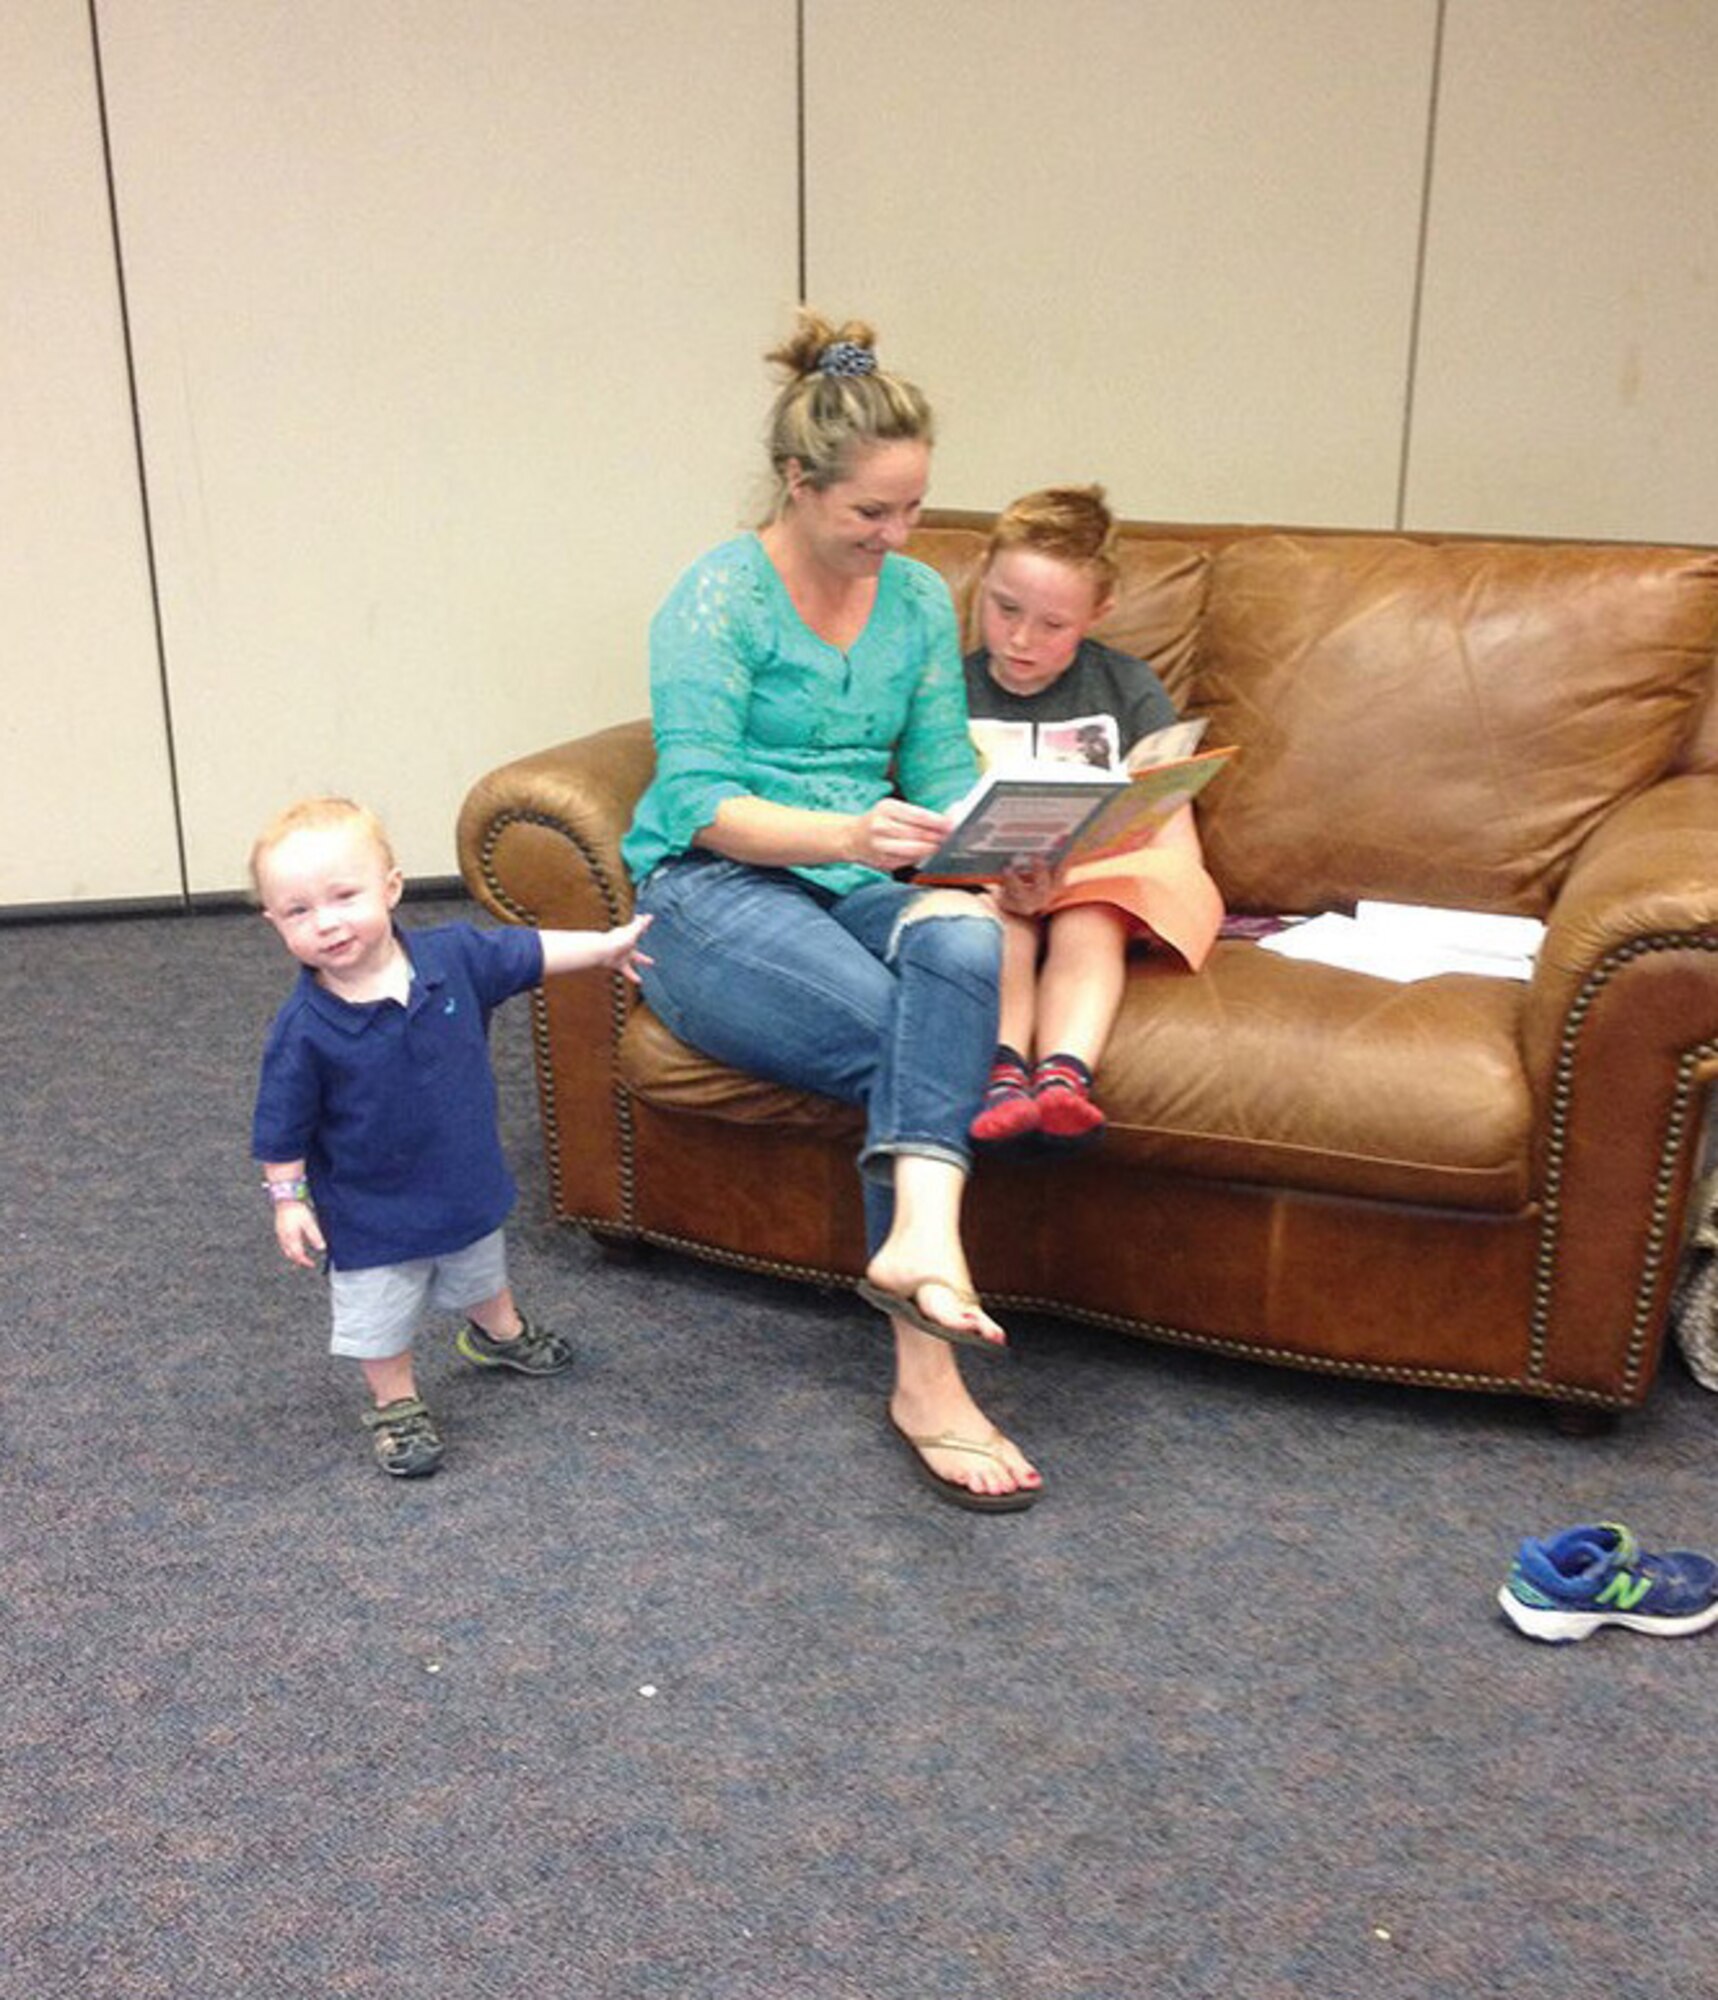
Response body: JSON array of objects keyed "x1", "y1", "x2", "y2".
[{"x1": 806, "y1": 0, "x2": 1436, "y2": 526}]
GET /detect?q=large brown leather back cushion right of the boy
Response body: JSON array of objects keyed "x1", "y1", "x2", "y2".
[{"x1": 1194, "y1": 534, "x2": 1718, "y2": 916}]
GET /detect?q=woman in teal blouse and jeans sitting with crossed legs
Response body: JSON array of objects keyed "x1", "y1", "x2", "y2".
[{"x1": 624, "y1": 310, "x2": 1042, "y2": 1512}]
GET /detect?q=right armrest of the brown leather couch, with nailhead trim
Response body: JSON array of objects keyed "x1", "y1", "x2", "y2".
[{"x1": 1522, "y1": 774, "x2": 1718, "y2": 1382}]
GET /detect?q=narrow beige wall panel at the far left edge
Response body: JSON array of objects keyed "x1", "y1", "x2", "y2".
[{"x1": 0, "y1": 0, "x2": 180, "y2": 908}]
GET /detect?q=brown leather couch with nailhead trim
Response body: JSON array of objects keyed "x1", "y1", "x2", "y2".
[{"x1": 460, "y1": 514, "x2": 1718, "y2": 1410}]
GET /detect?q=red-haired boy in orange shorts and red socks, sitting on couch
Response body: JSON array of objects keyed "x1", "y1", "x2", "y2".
[{"x1": 966, "y1": 486, "x2": 1222, "y2": 1146}]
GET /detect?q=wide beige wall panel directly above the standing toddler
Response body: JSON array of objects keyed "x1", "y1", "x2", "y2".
[{"x1": 104, "y1": 0, "x2": 796, "y2": 890}]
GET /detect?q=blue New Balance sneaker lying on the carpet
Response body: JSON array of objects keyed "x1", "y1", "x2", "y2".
[{"x1": 1498, "y1": 1520, "x2": 1718, "y2": 1642}]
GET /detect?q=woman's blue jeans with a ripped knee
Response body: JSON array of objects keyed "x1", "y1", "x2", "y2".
[{"x1": 638, "y1": 852, "x2": 1002, "y2": 1250}]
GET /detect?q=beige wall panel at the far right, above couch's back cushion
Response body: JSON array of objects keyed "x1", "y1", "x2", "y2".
[{"x1": 1408, "y1": 0, "x2": 1718, "y2": 542}]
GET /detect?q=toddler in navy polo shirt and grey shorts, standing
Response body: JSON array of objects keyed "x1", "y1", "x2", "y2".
[{"x1": 250, "y1": 798, "x2": 650, "y2": 1478}]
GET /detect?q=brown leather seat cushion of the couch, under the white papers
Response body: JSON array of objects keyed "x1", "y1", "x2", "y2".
[{"x1": 620, "y1": 942, "x2": 1534, "y2": 1214}]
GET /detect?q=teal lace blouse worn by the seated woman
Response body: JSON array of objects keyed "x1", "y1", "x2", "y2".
[{"x1": 620, "y1": 534, "x2": 978, "y2": 892}]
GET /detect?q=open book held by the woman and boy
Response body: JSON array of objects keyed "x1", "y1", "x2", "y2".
[{"x1": 916, "y1": 722, "x2": 1234, "y2": 886}]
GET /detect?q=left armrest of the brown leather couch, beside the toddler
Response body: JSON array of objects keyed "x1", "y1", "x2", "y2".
[{"x1": 458, "y1": 722, "x2": 654, "y2": 1234}]
